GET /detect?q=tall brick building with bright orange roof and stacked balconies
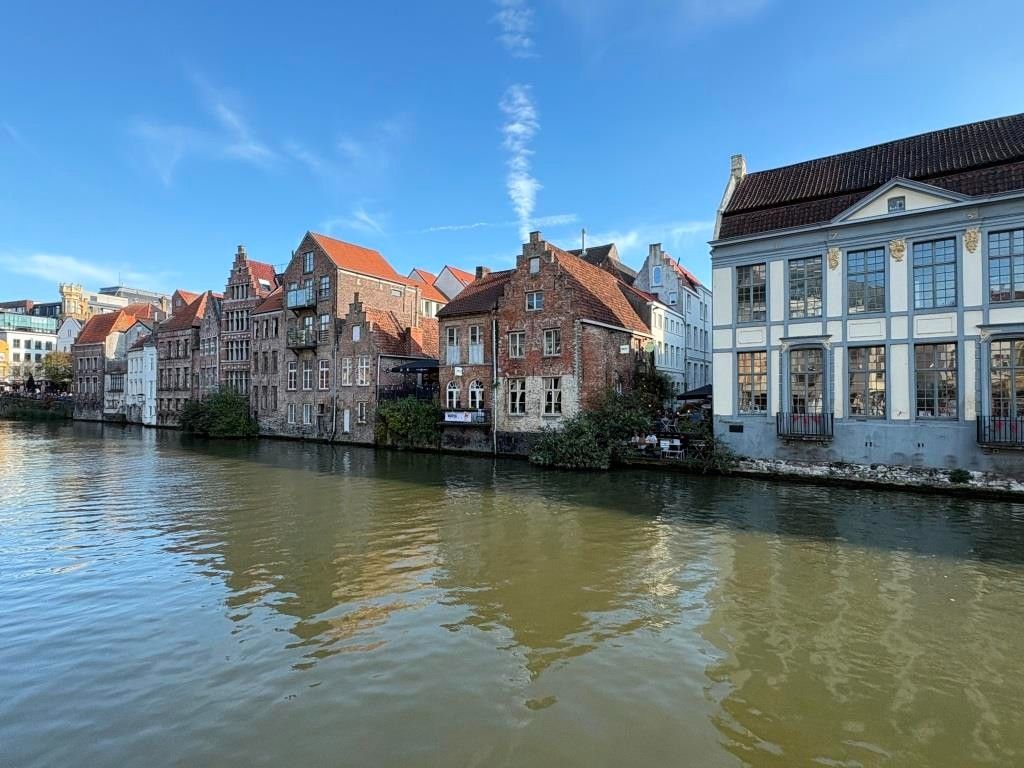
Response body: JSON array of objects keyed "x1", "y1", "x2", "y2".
[{"x1": 274, "y1": 232, "x2": 421, "y2": 438}]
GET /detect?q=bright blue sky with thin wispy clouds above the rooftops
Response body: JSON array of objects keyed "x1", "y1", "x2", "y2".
[{"x1": 0, "y1": 0, "x2": 1024, "y2": 300}]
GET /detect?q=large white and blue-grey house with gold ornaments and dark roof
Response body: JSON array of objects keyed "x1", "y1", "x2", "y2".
[{"x1": 712, "y1": 115, "x2": 1024, "y2": 475}]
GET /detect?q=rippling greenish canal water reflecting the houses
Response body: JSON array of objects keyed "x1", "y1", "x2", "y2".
[{"x1": 0, "y1": 422, "x2": 1024, "y2": 768}]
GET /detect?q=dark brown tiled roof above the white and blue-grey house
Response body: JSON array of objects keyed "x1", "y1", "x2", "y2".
[{"x1": 719, "y1": 113, "x2": 1024, "y2": 238}]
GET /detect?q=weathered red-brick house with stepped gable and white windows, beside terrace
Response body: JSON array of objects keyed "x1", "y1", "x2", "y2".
[{"x1": 438, "y1": 232, "x2": 651, "y2": 453}]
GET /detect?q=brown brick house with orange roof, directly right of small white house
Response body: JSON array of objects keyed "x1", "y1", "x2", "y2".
[{"x1": 156, "y1": 291, "x2": 211, "y2": 426}]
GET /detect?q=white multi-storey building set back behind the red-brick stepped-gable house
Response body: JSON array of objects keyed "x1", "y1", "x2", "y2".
[{"x1": 633, "y1": 243, "x2": 712, "y2": 393}]
